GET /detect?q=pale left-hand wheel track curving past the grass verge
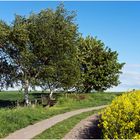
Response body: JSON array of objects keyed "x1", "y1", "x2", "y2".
[{"x1": 5, "y1": 105, "x2": 106, "y2": 139}]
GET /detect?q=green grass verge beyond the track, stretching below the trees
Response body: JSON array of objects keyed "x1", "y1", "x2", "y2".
[{"x1": 0, "y1": 92, "x2": 121, "y2": 138}]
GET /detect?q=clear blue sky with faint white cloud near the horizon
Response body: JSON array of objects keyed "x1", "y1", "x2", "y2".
[{"x1": 0, "y1": 1, "x2": 140, "y2": 91}]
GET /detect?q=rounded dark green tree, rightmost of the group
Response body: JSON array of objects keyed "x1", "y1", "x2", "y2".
[{"x1": 79, "y1": 36, "x2": 124, "y2": 92}]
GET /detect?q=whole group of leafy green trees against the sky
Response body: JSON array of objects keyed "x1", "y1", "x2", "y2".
[{"x1": 0, "y1": 4, "x2": 124, "y2": 104}]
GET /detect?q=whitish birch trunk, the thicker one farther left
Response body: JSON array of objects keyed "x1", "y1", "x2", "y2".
[{"x1": 24, "y1": 80, "x2": 29, "y2": 106}]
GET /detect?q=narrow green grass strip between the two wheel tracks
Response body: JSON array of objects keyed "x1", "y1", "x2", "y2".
[{"x1": 33, "y1": 111, "x2": 97, "y2": 139}]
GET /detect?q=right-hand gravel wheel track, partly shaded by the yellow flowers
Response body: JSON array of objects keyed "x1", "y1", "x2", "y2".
[{"x1": 63, "y1": 114, "x2": 101, "y2": 139}]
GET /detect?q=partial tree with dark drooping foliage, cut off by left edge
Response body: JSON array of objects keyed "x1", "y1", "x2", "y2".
[{"x1": 0, "y1": 21, "x2": 16, "y2": 90}]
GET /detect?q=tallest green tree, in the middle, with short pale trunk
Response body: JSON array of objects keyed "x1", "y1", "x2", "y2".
[{"x1": 29, "y1": 4, "x2": 80, "y2": 98}]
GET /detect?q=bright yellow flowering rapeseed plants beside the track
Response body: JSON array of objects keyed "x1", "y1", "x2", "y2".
[{"x1": 99, "y1": 91, "x2": 140, "y2": 139}]
